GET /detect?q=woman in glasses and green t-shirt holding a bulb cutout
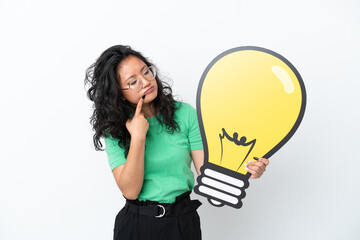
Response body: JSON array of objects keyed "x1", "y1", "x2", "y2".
[{"x1": 85, "y1": 45, "x2": 268, "y2": 240}]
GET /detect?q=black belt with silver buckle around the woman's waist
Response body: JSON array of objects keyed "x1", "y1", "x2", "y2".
[{"x1": 125, "y1": 191, "x2": 201, "y2": 218}]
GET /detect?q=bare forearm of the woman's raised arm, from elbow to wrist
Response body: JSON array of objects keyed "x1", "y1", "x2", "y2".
[{"x1": 117, "y1": 138, "x2": 145, "y2": 199}]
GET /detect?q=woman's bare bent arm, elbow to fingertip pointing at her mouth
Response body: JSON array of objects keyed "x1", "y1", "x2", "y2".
[{"x1": 113, "y1": 98, "x2": 149, "y2": 199}]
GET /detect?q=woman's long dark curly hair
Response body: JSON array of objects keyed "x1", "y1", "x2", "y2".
[{"x1": 84, "y1": 45, "x2": 179, "y2": 156}]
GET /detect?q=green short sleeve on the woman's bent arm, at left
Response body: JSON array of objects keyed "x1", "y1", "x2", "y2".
[{"x1": 104, "y1": 137, "x2": 126, "y2": 171}]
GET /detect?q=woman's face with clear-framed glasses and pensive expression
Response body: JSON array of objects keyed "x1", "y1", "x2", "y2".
[{"x1": 117, "y1": 55, "x2": 158, "y2": 105}]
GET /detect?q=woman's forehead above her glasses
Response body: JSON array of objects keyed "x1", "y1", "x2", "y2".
[{"x1": 117, "y1": 55, "x2": 146, "y2": 79}]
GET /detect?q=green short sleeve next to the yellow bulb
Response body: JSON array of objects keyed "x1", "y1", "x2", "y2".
[{"x1": 188, "y1": 104, "x2": 203, "y2": 150}]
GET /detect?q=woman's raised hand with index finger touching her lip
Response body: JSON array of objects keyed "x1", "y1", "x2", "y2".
[{"x1": 126, "y1": 95, "x2": 149, "y2": 139}]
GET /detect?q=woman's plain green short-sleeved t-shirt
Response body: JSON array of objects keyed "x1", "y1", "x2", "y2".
[{"x1": 105, "y1": 102, "x2": 203, "y2": 203}]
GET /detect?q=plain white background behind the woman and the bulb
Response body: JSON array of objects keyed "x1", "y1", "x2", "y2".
[{"x1": 0, "y1": 0, "x2": 360, "y2": 240}]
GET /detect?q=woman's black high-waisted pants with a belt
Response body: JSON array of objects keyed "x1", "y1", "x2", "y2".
[{"x1": 114, "y1": 191, "x2": 201, "y2": 240}]
